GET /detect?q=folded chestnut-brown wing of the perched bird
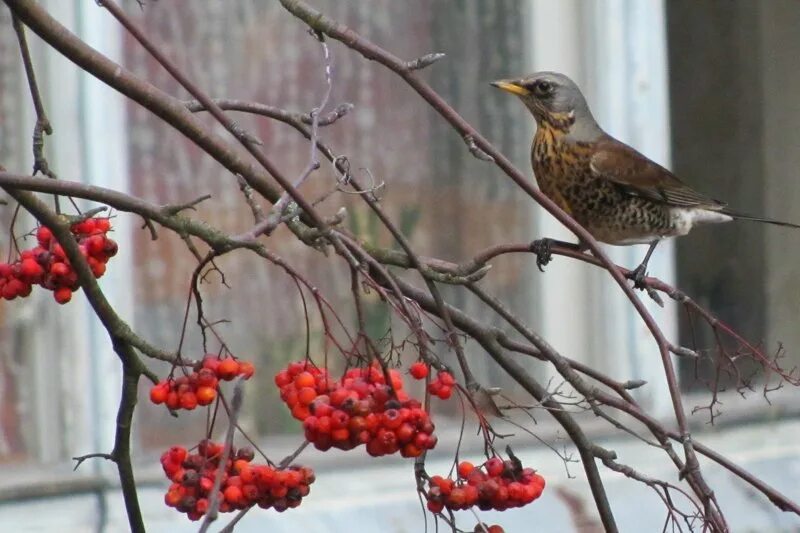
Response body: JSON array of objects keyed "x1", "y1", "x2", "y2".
[{"x1": 590, "y1": 139, "x2": 726, "y2": 211}]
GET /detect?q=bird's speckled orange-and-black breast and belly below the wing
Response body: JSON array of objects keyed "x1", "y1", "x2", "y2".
[{"x1": 531, "y1": 122, "x2": 679, "y2": 244}]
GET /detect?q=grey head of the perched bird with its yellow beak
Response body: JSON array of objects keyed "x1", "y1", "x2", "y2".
[{"x1": 492, "y1": 72, "x2": 595, "y2": 134}]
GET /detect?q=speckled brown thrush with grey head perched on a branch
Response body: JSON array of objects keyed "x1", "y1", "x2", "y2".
[{"x1": 492, "y1": 72, "x2": 800, "y2": 287}]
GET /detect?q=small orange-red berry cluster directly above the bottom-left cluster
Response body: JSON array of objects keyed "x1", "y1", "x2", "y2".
[{"x1": 150, "y1": 354, "x2": 255, "y2": 411}]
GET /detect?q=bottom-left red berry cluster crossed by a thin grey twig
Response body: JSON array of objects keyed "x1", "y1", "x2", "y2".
[{"x1": 161, "y1": 440, "x2": 315, "y2": 520}]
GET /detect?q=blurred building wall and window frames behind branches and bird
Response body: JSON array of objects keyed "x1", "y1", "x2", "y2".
[{"x1": 0, "y1": 0, "x2": 800, "y2": 532}]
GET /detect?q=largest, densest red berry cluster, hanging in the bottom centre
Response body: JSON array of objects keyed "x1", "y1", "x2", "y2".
[{"x1": 275, "y1": 362, "x2": 437, "y2": 457}]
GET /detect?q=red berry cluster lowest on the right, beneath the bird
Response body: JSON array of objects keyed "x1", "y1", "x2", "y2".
[{"x1": 426, "y1": 457, "x2": 544, "y2": 513}]
